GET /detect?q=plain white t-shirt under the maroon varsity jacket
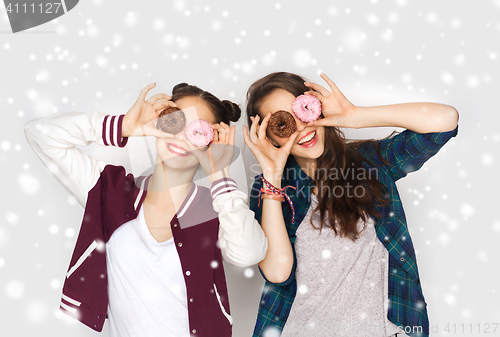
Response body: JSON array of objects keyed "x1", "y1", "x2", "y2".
[{"x1": 106, "y1": 206, "x2": 189, "y2": 337}]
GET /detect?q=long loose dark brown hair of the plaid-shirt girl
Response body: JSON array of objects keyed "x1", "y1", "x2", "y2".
[{"x1": 246, "y1": 72, "x2": 392, "y2": 241}]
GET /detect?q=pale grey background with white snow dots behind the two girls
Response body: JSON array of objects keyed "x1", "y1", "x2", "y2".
[{"x1": 0, "y1": 0, "x2": 500, "y2": 337}]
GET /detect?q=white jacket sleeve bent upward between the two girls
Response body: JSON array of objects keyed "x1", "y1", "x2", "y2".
[{"x1": 211, "y1": 178, "x2": 268, "y2": 267}]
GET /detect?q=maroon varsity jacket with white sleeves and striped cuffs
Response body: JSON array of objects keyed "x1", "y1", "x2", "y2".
[{"x1": 25, "y1": 110, "x2": 267, "y2": 337}]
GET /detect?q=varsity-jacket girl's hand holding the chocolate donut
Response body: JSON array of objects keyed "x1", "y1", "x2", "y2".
[{"x1": 122, "y1": 83, "x2": 176, "y2": 137}]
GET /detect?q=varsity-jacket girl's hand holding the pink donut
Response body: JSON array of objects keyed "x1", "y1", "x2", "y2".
[{"x1": 186, "y1": 122, "x2": 236, "y2": 181}]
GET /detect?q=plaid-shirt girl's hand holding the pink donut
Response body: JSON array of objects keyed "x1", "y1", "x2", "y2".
[{"x1": 304, "y1": 73, "x2": 356, "y2": 127}]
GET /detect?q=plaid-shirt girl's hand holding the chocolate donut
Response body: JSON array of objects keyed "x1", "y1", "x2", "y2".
[{"x1": 243, "y1": 114, "x2": 299, "y2": 187}]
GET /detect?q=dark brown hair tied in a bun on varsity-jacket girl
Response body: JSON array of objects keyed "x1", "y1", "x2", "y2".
[{"x1": 172, "y1": 83, "x2": 241, "y2": 125}]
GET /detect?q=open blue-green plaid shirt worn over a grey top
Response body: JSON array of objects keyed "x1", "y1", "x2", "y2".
[{"x1": 250, "y1": 125, "x2": 458, "y2": 337}]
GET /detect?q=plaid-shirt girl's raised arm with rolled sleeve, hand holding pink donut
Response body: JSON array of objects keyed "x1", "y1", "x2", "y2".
[{"x1": 306, "y1": 74, "x2": 459, "y2": 181}]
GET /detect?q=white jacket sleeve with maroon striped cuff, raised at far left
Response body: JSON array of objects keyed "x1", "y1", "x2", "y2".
[{"x1": 24, "y1": 109, "x2": 128, "y2": 207}]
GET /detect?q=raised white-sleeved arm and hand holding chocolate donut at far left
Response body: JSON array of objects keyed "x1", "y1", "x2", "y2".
[{"x1": 24, "y1": 84, "x2": 178, "y2": 207}]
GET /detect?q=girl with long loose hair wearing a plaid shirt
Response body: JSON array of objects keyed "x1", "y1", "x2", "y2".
[{"x1": 244, "y1": 72, "x2": 458, "y2": 337}]
